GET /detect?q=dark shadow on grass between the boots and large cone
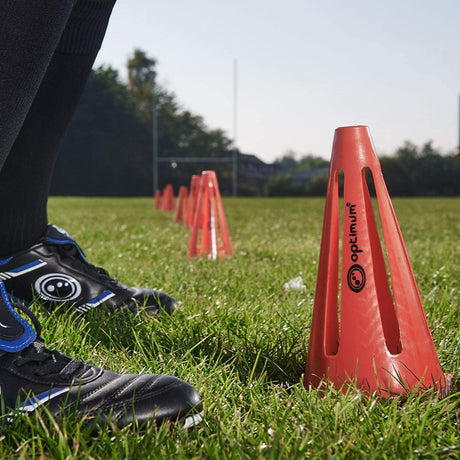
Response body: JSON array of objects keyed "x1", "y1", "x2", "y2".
[{"x1": 75, "y1": 311, "x2": 306, "y2": 385}]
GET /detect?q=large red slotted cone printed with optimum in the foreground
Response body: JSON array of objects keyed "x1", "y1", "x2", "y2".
[{"x1": 305, "y1": 126, "x2": 449, "y2": 396}]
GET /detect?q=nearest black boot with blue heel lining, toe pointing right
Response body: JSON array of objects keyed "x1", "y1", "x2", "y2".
[{"x1": 0, "y1": 281, "x2": 202, "y2": 428}]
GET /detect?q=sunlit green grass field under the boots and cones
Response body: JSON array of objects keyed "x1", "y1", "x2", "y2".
[{"x1": 0, "y1": 198, "x2": 460, "y2": 459}]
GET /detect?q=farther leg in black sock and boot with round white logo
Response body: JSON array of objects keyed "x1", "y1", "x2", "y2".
[{"x1": 0, "y1": 0, "x2": 177, "y2": 314}]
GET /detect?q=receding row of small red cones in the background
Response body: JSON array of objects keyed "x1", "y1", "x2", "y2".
[{"x1": 154, "y1": 171, "x2": 233, "y2": 259}]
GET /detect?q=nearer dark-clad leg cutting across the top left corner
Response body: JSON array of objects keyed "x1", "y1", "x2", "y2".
[{"x1": 0, "y1": 0, "x2": 73, "y2": 164}]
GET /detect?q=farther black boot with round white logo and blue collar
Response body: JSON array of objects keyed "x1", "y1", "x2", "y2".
[{"x1": 0, "y1": 225, "x2": 177, "y2": 314}]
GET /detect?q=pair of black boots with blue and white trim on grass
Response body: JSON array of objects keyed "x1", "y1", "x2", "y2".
[{"x1": 0, "y1": 226, "x2": 202, "y2": 427}]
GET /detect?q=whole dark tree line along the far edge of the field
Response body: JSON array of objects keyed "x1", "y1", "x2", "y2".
[{"x1": 51, "y1": 50, "x2": 460, "y2": 196}]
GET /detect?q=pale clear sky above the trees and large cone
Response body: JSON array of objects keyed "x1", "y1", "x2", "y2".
[{"x1": 96, "y1": 0, "x2": 460, "y2": 162}]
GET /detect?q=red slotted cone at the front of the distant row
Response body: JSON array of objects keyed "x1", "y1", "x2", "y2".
[{"x1": 188, "y1": 171, "x2": 233, "y2": 259}]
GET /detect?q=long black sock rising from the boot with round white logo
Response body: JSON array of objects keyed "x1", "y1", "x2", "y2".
[{"x1": 0, "y1": 0, "x2": 115, "y2": 256}]
